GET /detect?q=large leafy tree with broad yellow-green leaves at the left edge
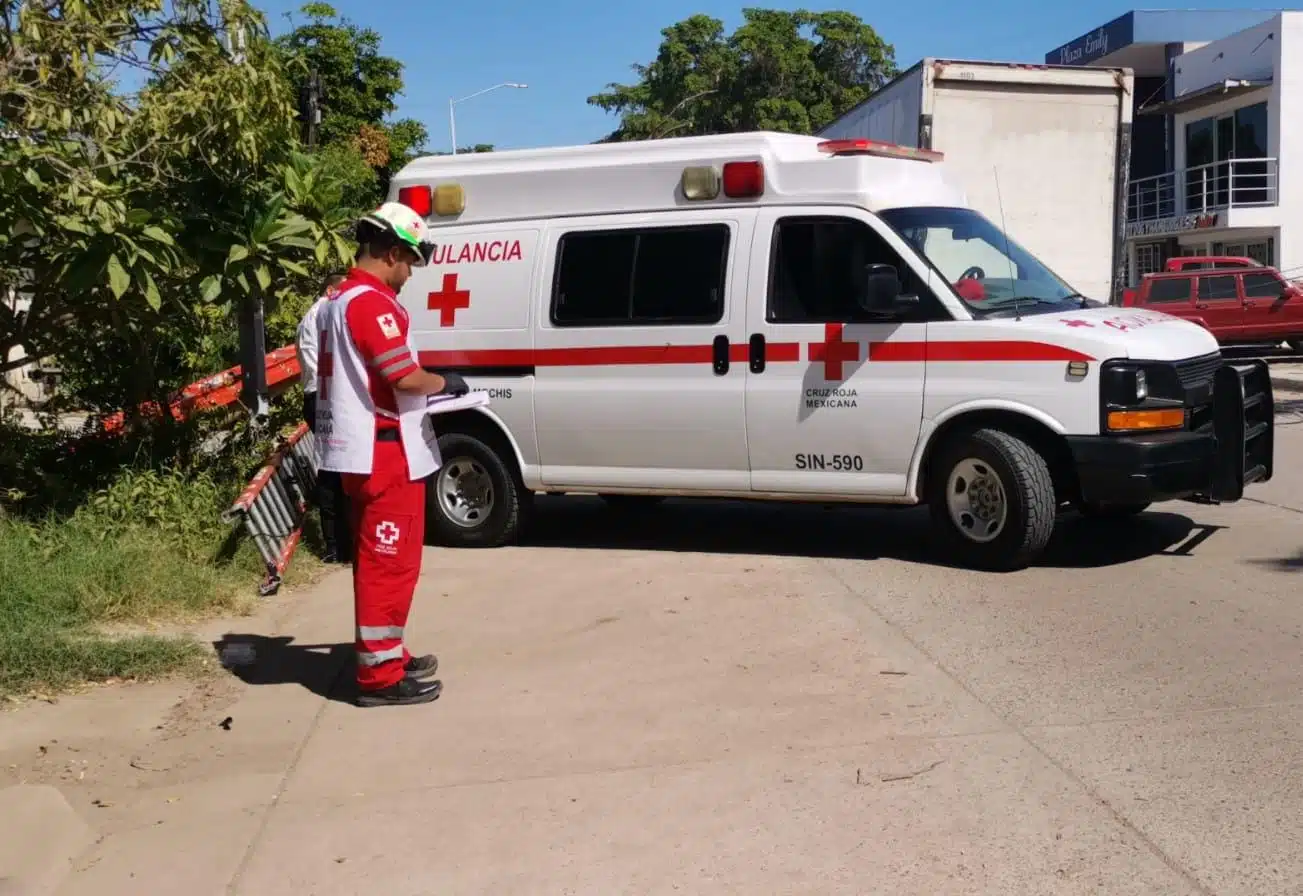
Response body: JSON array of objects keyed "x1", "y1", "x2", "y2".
[{"x1": 0, "y1": 0, "x2": 357, "y2": 419}]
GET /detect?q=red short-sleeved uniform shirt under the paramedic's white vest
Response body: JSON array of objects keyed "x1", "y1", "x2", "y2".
[{"x1": 339, "y1": 267, "x2": 420, "y2": 428}]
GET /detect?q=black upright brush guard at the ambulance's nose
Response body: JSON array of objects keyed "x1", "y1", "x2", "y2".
[{"x1": 1194, "y1": 359, "x2": 1276, "y2": 503}]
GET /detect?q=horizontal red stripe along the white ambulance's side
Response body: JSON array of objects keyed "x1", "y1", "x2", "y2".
[{"x1": 418, "y1": 341, "x2": 1095, "y2": 369}]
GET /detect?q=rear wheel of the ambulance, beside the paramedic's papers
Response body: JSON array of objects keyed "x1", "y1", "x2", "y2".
[{"x1": 425, "y1": 432, "x2": 533, "y2": 547}]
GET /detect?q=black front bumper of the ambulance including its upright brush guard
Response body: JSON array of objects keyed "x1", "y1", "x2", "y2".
[{"x1": 1067, "y1": 361, "x2": 1276, "y2": 504}]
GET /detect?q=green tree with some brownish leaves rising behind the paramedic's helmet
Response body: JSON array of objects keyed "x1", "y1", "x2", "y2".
[{"x1": 275, "y1": 3, "x2": 427, "y2": 194}]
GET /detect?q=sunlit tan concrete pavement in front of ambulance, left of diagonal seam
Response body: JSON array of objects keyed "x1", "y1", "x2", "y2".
[{"x1": 0, "y1": 531, "x2": 1197, "y2": 896}]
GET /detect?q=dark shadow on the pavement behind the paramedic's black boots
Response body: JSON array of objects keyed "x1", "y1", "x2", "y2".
[{"x1": 212, "y1": 634, "x2": 354, "y2": 703}]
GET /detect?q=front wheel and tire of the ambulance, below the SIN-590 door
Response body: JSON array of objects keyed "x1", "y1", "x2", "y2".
[{"x1": 928, "y1": 430, "x2": 1058, "y2": 572}]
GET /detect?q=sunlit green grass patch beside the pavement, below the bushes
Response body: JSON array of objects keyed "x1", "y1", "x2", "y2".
[{"x1": 0, "y1": 471, "x2": 267, "y2": 694}]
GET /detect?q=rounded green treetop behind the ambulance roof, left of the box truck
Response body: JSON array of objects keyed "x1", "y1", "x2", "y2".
[{"x1": 588, "y1": 8, "x2": 896, "y2": 141}]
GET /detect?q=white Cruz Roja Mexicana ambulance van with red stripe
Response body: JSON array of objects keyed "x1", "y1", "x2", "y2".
[{"x1": 391, "y1": 133, "x2": 1273, "y2": 569}]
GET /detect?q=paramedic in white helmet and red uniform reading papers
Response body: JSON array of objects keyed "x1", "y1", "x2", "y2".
[{"x1": 317, "y1": 202, "x2": 468, "y2": 706}]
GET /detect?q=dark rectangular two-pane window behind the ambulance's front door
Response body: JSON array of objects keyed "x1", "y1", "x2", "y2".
[{"x1": 551, "y1": 224, "x2": 730, "y2": 327}]
